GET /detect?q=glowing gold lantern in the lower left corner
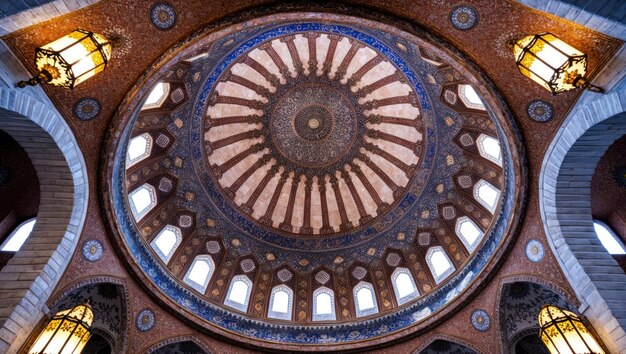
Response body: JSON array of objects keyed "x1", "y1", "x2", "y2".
[{"x1": 28, "y1": 304, "x2": 93, "y2": 354}]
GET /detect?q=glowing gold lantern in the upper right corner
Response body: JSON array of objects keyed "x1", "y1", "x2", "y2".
[{"x1": 509, "y1": 32, "x2": 603, "y2": 95}]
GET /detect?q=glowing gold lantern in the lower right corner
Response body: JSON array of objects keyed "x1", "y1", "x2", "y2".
[{"x1": 539, "y1": 305, "x2": 605, "y2": 354}]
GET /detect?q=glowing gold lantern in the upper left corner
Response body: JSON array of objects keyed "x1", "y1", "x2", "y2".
[{"x1": 17, "y1": 29, "x2": 112, "y2": 89}]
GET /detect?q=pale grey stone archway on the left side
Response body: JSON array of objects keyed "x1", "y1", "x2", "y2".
[{"x1": 0, "y1": 87, "x2": 89, "y2": 353}]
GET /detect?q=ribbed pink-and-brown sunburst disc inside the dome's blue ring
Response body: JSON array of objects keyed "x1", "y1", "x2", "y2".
[{"x1": 204, "y1": 32, "x2": 424, "y2": 236}]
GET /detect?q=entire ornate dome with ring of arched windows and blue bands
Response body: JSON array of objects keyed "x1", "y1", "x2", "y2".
[{"x1": 105, "y1": 9, "x2": 524, "y2": 350}]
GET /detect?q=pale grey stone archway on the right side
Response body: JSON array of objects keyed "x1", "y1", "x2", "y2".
[{"x1": 539, "y1": 91, "x2": 626, "y2": 353}]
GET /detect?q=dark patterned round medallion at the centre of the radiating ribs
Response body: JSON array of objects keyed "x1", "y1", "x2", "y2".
[{"x1": 270, "y1": 83, "x2": 357, "y2": 168}]
